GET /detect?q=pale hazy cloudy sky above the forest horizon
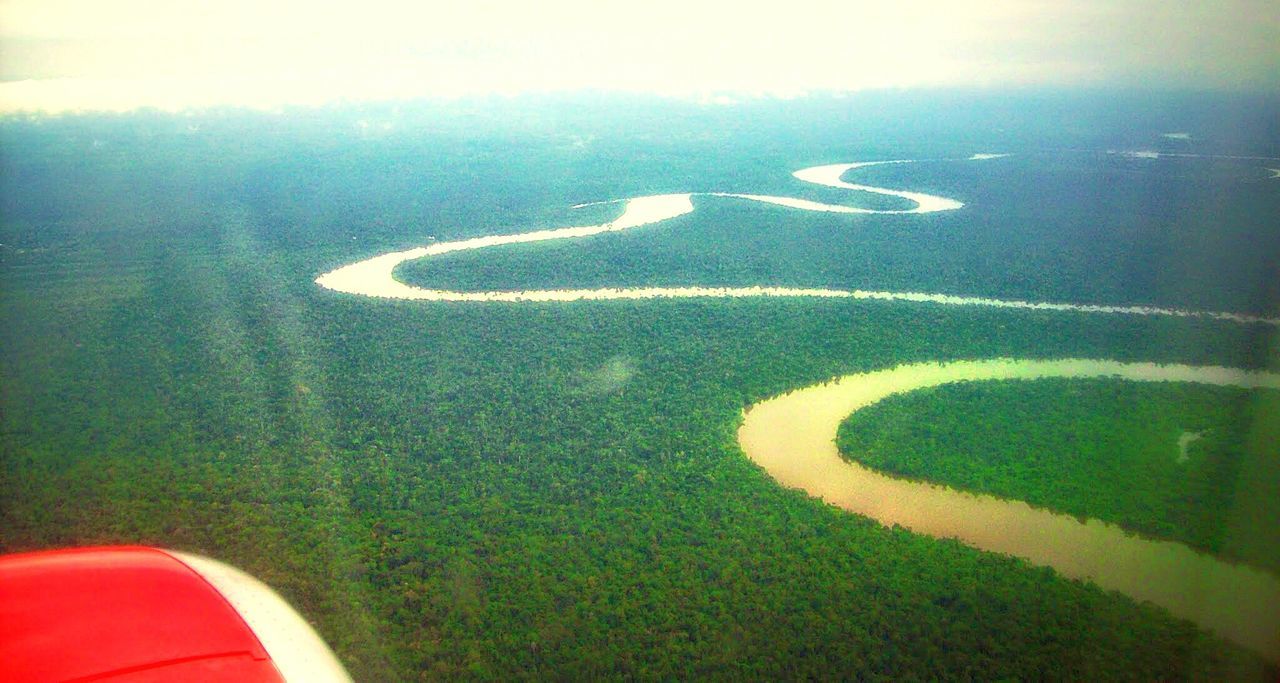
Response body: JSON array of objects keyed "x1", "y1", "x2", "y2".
[{"x1": 0, "y1": 0, "x2": 1280, "y2": 110}]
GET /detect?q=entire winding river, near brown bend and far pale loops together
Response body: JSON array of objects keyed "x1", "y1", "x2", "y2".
[{"x1": 316, "y1": 153, "x2": 1280, "y2": 663}]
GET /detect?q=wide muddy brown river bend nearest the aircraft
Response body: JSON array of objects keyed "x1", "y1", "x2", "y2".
[{"x1": 737, "y1": 359, "x2": 1280, "y2": 661}]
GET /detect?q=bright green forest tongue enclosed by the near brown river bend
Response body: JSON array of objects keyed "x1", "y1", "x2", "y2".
[{"x1": 837, "y1": 379, "x2": 1280, "y2": 574}]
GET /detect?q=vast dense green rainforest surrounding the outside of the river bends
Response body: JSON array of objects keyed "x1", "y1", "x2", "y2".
[{"x1": 0, "y1": 93, "x2": 1280, "y2": 680}]
